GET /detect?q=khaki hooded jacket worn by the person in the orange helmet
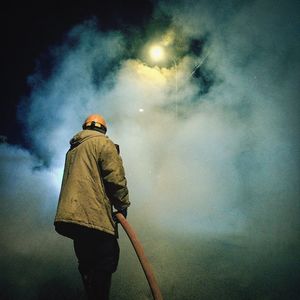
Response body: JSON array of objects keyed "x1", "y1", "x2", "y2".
[{"x1": 54, "y1": 130, "x2": 130, "y2": 238}]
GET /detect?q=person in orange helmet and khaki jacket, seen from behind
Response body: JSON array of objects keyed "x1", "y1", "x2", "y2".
[{"x1": 54, "y1": 114, "x2": 130, "y2": 300}]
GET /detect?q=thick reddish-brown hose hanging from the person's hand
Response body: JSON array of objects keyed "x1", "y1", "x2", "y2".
[{"x1": 116, "y1": 213, "x2": 163, "y2": 300}]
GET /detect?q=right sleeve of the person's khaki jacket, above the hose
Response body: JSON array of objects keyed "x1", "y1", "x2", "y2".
[{"x1": 99, "y1": 139, "x2": 130, "y2": 210}]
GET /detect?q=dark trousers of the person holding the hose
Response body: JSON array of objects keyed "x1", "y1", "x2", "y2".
[{"x1": 74, "y1": 232, "x2": 120, "y2": 300}]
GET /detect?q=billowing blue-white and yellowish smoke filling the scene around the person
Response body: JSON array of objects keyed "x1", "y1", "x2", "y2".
[{"x1": 1, "y1": 1, "x2": 300, "y2": 299}]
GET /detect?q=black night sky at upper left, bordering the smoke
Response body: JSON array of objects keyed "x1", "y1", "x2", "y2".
[{"x1": 0, "y1": 0, "x2": 153, "y2": 144}]
